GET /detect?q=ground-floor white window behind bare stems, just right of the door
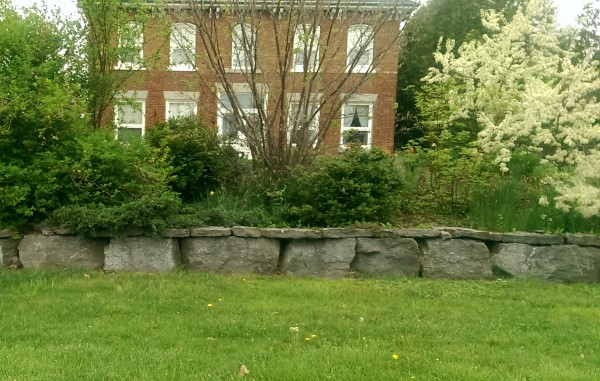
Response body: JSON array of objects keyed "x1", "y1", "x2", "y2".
[{"x1": 288, "y1": 100, "x2": 320, "y2": 146}]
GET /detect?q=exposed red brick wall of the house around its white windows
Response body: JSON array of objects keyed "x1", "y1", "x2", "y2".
[{"x1": 116, "y1": 13, "x2": 399, "y2": 152}]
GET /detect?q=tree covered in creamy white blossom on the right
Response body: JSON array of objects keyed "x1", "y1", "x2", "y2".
[{"x1": 423, "y1": 0, "x2": 600, "y2": 217}]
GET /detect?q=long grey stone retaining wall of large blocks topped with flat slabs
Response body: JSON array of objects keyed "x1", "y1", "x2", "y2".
[{"x1": 0, "y1": 227, "x2": 600, "y2": 282}]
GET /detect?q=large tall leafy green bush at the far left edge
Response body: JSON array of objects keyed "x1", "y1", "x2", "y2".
[{"x1": 0, "y1": 1, "x2": 84, "y2": 229}]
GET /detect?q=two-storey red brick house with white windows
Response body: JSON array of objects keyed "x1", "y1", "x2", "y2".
[{"x1": 114, "y1": 0, "x2": 416, "y2": 153}]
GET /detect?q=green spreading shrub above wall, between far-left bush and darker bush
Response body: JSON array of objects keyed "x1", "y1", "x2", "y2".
[{"x1": 53, "y1": 130, "x2": 181, "y2": 235}]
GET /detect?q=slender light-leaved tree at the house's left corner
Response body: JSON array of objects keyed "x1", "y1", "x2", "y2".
[{"x1": 77, "y1": 0, "x2": 167, "y2": 128}]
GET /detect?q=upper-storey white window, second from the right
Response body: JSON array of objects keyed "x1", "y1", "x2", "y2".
[{"x1": 292, "y1": 24, "x2": 321, "y2": 72}]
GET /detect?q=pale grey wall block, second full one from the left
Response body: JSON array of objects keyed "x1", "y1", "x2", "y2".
[{"x1": 104, "y1": 237, "x2": 181, "y2": 272}]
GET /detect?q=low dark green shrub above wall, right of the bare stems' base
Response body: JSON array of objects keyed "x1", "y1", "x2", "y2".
[{"x1": 285, "y1": 148, "x2": 402, "y2": 226}]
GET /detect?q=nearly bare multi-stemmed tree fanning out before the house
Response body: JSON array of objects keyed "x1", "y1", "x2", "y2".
[{"x1": 175, "y1": 0, "x2": 416, "y2": 171}]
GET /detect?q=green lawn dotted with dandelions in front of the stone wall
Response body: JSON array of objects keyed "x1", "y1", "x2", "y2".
[{"x1": 0, "y1": 271, "x2": 600, "y2": 381}]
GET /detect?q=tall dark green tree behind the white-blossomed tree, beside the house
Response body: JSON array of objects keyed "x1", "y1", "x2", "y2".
[{"x1": 396, "y1": 0, "x2": 518, "y2": 146}]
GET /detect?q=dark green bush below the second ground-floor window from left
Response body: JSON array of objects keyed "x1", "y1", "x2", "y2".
[{"x1": 146, "y1": 116, "x2": 239, "y2": 202}]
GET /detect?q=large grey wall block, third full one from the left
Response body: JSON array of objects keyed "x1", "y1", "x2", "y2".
[{"x1": 181, "y1": 236, "x2": 279, "y2": 274}]
